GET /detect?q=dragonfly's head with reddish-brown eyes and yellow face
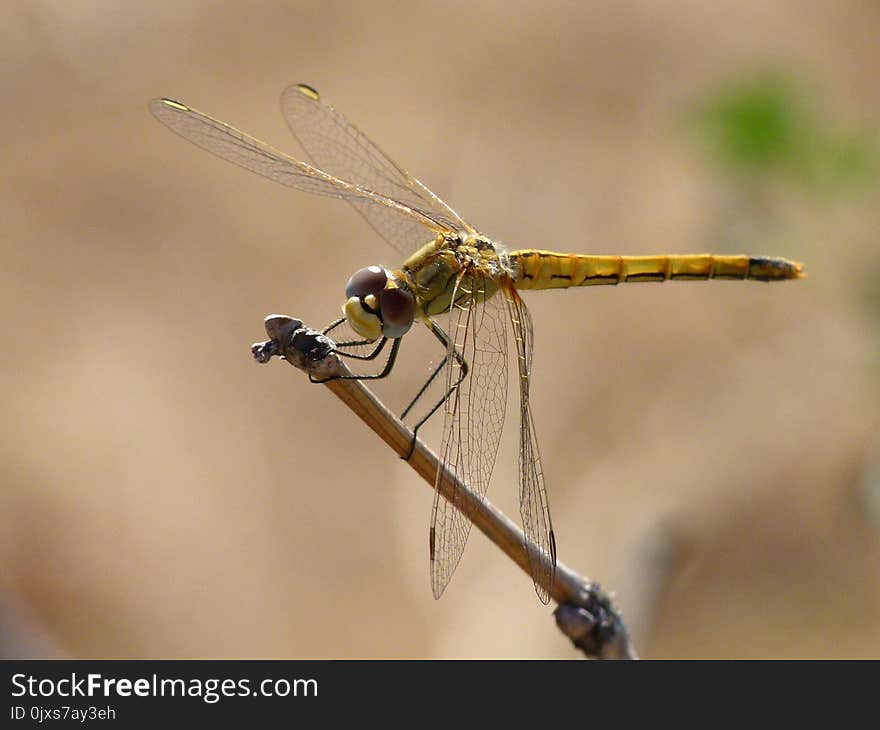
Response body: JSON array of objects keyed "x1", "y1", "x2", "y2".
[{"x1": 342, "y1": 266, "x2": 416, "y2": 340}]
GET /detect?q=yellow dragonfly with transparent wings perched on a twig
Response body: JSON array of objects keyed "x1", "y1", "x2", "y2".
[{"x1": 150, "y1": 84, "x2": 804, "y2": 604}]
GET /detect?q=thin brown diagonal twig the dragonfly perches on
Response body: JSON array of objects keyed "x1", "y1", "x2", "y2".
[{"x1": 251, "y1": 315, "x2": 637, "y2": 659}]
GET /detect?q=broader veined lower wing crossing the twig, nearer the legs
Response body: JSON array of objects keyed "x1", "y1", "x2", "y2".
[{"x1": 431, "y1": 273, "x2": 507, "y2": 598}]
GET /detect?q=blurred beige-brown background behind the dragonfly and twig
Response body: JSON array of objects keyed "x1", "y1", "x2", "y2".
[{"x1": 0, "y1": 0, "x2": 880, "y2": 658}]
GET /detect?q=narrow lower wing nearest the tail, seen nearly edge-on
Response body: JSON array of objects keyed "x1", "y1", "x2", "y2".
[{"x1": 502, "y1": 282, "x2": 556, "y2": 603}]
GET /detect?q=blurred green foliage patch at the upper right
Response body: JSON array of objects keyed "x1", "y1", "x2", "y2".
[{"x1": 695, "y1": 74, "x2": 880, "y2": 194}]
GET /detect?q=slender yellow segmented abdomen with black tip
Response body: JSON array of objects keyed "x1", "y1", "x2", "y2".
[{"x1": 508, "y1": 249, "x2": 806, "y2": 289}]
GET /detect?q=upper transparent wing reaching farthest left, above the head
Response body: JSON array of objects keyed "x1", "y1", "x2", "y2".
[{"x1": 150, "y1": 99, "x2": 454, "y2": 237}]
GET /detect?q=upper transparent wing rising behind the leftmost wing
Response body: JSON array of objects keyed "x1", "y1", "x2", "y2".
[{"x1": 281, "y1": 84, "x2": 476, "y2": 255}]
